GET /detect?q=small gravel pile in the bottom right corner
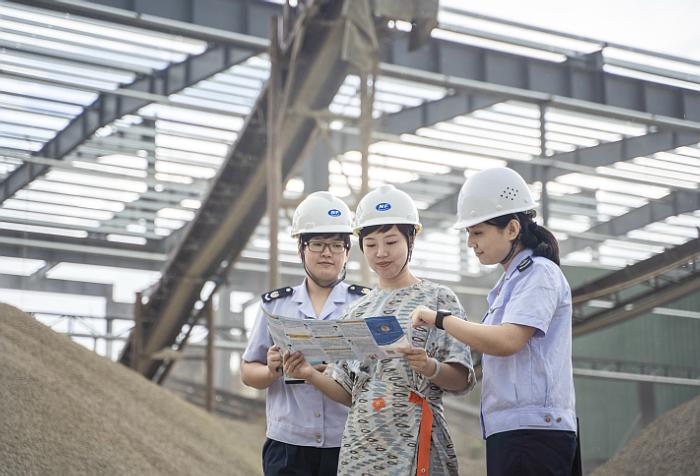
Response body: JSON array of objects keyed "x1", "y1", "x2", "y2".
[{"x1": 593, "y1": 397, "x2": 700, "y2": 476}]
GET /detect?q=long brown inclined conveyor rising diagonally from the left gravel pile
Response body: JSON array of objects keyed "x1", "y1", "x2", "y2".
[{"x1": 121, "y1": 0, "x2": 356, "y2": 378}]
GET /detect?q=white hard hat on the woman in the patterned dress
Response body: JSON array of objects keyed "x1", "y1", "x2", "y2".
[{"x1": 353, "y1": 185, "x2": 421, "y2": 235}]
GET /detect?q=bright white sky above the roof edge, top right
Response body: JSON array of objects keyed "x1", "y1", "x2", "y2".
[{"x1": 448, "y1": 0, "x2": 700, "y2": 60}]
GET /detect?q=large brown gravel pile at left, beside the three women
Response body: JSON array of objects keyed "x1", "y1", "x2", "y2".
[{"x1": 0, "y1": 304, "x2": 262, "y2": 475}]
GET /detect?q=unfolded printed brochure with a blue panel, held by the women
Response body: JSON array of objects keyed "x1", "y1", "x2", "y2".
[{"x1": 267, "y1": 314, "x2": 410, "y2": 362}]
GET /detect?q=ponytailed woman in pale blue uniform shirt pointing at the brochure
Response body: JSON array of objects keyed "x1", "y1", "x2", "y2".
[{"x1": 412, "y1": 168, "x2": 577, "y2": 476}]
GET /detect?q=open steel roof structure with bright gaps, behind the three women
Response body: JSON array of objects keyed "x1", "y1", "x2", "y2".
[{"x1": 0, "y1": 0, "x2": 700, "y2": 372}]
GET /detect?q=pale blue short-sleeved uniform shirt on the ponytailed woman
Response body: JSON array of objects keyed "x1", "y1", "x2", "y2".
[{"x1": 481, "y1": 249, "x2": 576, "y2": 438}]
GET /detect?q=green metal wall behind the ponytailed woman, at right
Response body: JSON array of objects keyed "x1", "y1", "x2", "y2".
[{"x1": 565, "y1": 268, "x2": 700, "y2": 468}]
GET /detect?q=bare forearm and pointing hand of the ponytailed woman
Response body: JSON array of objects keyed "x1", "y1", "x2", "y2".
[{"x1": 411, "y1": 306, "x2": 536, "y2": 357}]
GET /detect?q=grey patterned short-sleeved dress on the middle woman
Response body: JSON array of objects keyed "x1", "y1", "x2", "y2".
[{"x1": 327, "y1": 280, "x2": 476, "y2": 476}]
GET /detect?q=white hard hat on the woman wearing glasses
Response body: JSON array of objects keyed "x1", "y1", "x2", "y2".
[{"x1": 292, "y1": 192, "x2": 352, "y2": 238}]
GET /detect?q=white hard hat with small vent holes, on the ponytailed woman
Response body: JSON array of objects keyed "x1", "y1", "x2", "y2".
[{"x1": 454, "y1": 167, "x2": 537, "y2": 229}]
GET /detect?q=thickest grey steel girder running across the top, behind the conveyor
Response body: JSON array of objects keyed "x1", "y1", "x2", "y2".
[{"x1": 17, "y1": 0, "x2": 700, "y2": 126}]
